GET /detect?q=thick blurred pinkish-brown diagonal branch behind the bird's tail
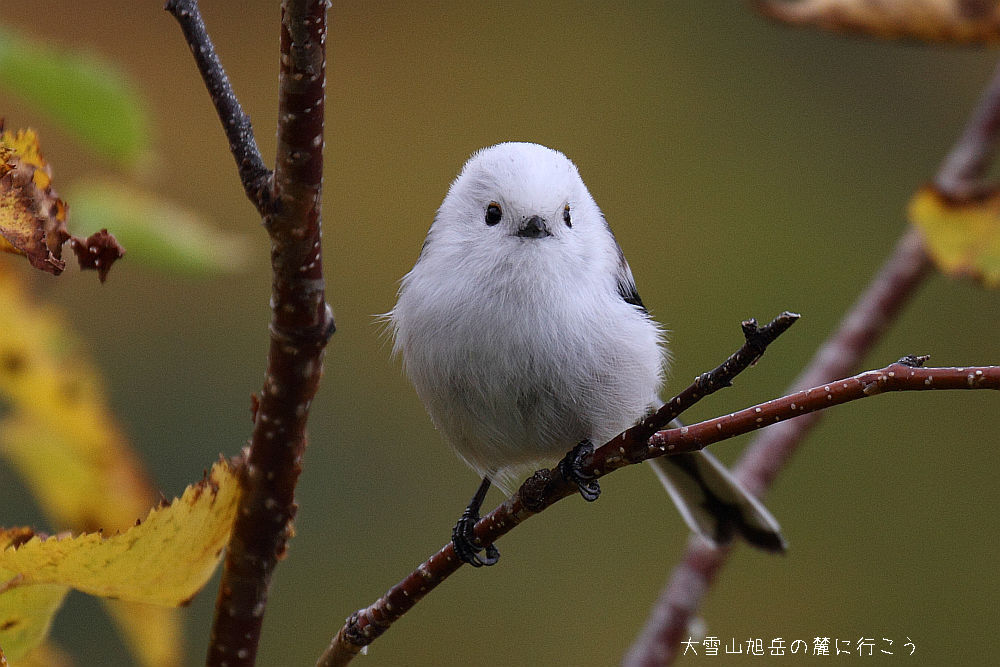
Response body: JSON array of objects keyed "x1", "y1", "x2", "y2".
[{"x1": 622, "y1": 47, "x2": 1000, "y2": 667}]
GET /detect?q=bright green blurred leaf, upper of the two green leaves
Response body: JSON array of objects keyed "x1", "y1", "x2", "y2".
[{"x1": 0, "y1": 28, "x2": 150, "y2": 166}]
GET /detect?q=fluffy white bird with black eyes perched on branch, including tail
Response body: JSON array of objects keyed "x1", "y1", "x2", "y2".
[{"x1": 388, "y1": 143, "x2": 784, "y2": 566}]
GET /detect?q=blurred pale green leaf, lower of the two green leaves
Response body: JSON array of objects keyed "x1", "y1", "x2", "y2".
[{"x1": 66, "y1": 181, "x2": 250, "y2": 276}]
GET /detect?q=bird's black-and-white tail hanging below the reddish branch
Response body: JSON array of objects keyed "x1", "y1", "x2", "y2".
[{"x1": 649, "y1": 452, "x2": 785, "y2": 553}]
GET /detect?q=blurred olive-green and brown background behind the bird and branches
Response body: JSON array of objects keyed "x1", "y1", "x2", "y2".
[{"x1": 0, "y1": 0, "x2": 1000, "y2": 666}]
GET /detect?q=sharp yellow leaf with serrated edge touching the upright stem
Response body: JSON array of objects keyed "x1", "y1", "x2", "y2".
[{"x1": 0, "y1": 461, "x2": 240, "y2": 606}]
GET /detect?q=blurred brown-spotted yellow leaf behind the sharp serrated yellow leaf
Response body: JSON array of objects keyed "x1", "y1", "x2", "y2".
[{"x1": 0, "y1": 258, "x2": 181, "y2": 667}]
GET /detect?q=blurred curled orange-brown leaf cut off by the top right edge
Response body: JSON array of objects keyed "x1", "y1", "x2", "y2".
[{"x1": 754, "y1": 0, "x2": 1000, "y2": 44}]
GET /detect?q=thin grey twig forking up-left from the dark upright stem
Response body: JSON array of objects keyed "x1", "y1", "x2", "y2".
[{"x1": 163, "y1": 0, "x2": 271, "y2": 215}]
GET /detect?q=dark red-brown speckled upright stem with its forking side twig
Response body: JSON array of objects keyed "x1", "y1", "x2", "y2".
[{"x1": 166, "y1": 0, "x2": 334, "y2": 667}]
